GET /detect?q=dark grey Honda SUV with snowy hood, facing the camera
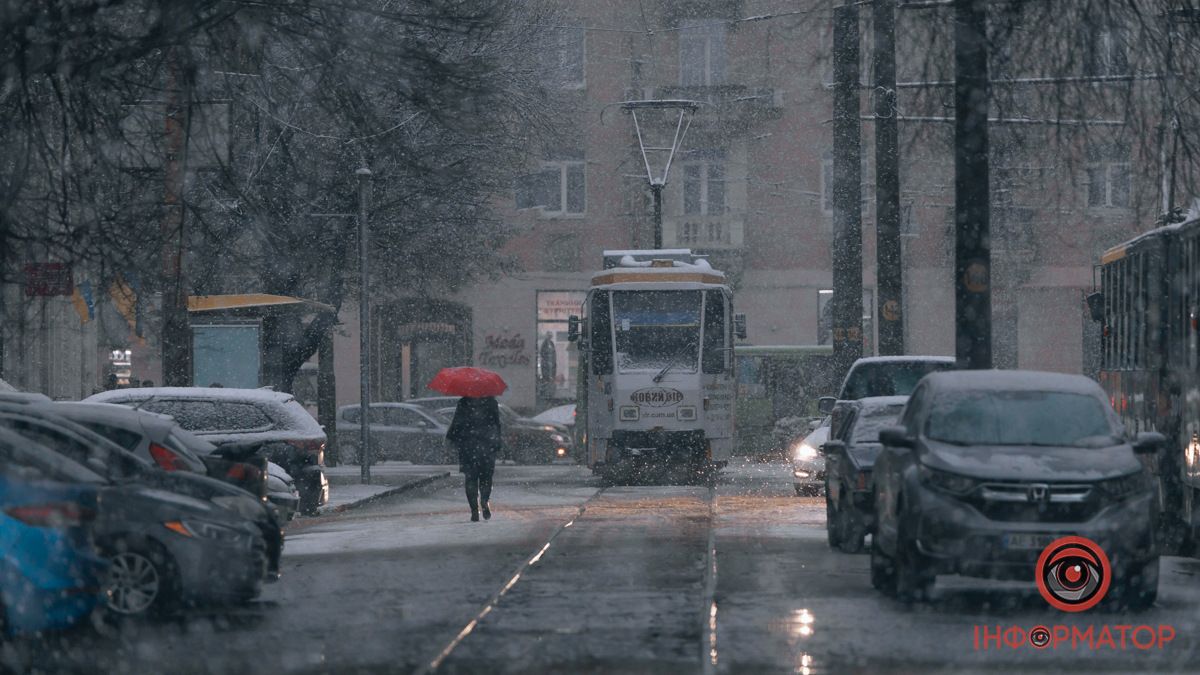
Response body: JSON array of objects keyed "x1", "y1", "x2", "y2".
[{"x1": 871, "y1": 370, "x2": 1163, "y2": 609}]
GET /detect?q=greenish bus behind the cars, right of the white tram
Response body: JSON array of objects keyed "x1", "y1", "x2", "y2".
[{"x1": 733, "y1": 345, "x2": 838, "y2": 456}]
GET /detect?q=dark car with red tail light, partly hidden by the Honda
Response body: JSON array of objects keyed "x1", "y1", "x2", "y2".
[{"x1": 821, "y1": 396, "x2": 908, "y2": 554}]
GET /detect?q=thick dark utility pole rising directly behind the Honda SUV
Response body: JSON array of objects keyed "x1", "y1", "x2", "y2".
[{"x1": 954, "y1": 0, "x2": 991, "y2": 369}]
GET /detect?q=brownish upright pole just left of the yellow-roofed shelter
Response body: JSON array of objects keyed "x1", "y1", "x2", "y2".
[{"x1": 160, "y1": 47, "x2": 192, "y2": 387}]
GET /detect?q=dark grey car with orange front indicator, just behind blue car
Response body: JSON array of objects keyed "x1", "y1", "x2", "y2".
[{"x1": 0, "y1": 404, "x2": 282, "y2": 605}]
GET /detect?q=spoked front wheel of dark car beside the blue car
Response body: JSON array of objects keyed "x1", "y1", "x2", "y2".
[{"x1": 104, "y1": 542, "x2": 179, "y2": 616}]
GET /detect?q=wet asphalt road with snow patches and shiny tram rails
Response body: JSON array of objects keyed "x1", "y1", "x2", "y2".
[{"x1": 14, "y1": 456, "x2": 1200, "y2": 673}]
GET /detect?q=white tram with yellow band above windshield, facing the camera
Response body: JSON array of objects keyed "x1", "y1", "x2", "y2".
[{"x1": 568, "y1": 249, "x2": 745, "y2": 482}]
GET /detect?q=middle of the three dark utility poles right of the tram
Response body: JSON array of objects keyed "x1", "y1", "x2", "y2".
[{"x1": 872, "y1": 0, "x2": 904, "y2": 357}]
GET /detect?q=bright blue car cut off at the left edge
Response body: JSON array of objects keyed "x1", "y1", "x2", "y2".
[{"x1": 0, "y1": 429, "x2": 108, "y2": 635}]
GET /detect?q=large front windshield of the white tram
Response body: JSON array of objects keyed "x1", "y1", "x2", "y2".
[{"x1": 612, "y1": 291, "x2": 701, "y2": 372}]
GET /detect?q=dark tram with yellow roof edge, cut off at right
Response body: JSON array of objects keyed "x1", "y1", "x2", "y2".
[{"x1": 1087, "y1": 220, "x2": 1200, "y2": 555}]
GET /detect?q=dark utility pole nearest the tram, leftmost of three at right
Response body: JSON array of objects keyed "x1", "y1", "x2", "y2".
[{"x1": 829, "y1": 4, "x2": 863, "y2": 372}]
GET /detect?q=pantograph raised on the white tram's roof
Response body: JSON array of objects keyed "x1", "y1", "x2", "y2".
[{"x1": 620, "y1": 100, "x2": 700, "y2": 249}]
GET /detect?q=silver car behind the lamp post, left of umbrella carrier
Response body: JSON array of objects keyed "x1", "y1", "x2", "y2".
[{"x1": 337, "y1": 402, "x2": 457, "y2": 464}]
